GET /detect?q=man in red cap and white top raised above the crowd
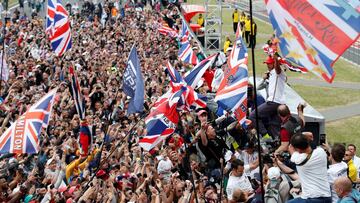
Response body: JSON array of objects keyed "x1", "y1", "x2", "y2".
[{"x1": 249, "y1": 55, "x2": 287, "y2": 138}]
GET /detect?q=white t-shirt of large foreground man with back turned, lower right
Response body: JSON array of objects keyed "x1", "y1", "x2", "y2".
[{"x1": 291, "y1": 147, "x2": 331, "y2": 199}]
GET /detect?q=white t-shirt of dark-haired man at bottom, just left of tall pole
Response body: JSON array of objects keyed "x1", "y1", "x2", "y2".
[{"x1": 226, "y1": 172, "x2": 253, "y2": 200}]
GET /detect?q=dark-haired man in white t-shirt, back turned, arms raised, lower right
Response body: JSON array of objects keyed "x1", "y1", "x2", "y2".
[{"x1": 289, "y1": 134, "x2": 331, "y2": 203}]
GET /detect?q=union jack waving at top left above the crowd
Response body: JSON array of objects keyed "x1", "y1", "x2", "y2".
[{"x1": 46, "y1": 0, "x2": 72, "y2": 56}]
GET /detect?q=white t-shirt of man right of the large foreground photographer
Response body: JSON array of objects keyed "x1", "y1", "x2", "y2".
[{"x1": 328, "y1": 162, "x2": 348, "y2": 203}]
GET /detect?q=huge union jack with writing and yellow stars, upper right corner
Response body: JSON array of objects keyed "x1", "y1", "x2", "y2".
[{"x1": 265, "y1": 0, "x2": 360, "y2": 83}]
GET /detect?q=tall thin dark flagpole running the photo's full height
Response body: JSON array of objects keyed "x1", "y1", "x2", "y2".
[{"x1": 249, "y1": 0, "x2": 265, "y2": 202}]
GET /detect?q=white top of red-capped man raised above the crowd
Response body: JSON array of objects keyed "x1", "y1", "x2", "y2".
[{"x1": 267, "y1": 68, "x2": 286, "y2": 104}]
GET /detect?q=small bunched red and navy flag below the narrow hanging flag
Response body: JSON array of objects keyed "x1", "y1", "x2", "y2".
[{"x1": 78, "y1": 120, "x2": 93, "y2": 156}]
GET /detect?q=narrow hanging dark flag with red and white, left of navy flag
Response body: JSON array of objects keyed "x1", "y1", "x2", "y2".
[{"x1": 69, "y1": 67, "x2": 85, "y2": 120}]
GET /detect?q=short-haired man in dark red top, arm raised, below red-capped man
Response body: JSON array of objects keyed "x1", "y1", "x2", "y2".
[{"x1": 275, "y1": 104, "x2": 305, "y2": 155}]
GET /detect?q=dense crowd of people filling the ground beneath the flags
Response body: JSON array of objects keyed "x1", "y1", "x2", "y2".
[{"x1": 0, "y1": 0, "x2": 360, "y2": 203}]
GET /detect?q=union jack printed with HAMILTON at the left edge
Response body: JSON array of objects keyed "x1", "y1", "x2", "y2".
[{"x1": 0, "y1": 89, "x2": 57, "y2": 154}]
